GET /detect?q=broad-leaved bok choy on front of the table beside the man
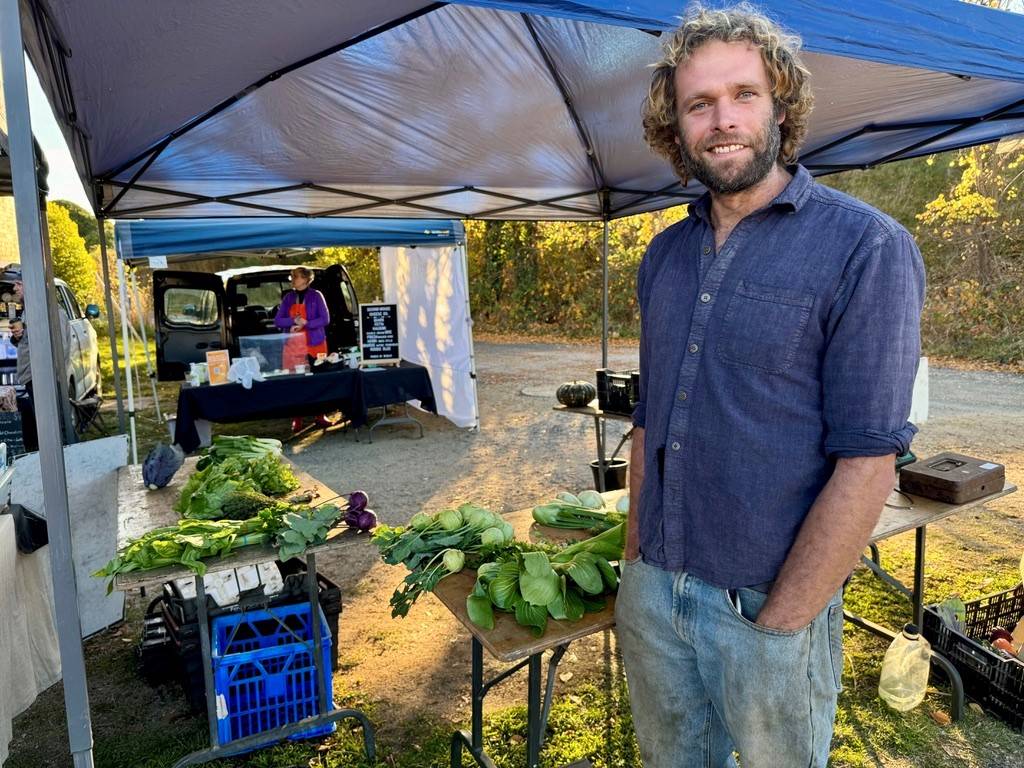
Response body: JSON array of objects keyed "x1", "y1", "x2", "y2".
[{"x1": 466, "y1": 523, "x2": 626, "y2": 637}]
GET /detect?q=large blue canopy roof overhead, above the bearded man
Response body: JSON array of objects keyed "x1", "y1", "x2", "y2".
[{"x1": 22, "y1": 0, "x2": 1024, "y2": 219}]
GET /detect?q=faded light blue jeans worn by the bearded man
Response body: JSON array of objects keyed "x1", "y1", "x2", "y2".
[{"x1": 615, "y1": 560, "x2": 843, "y2": 768}]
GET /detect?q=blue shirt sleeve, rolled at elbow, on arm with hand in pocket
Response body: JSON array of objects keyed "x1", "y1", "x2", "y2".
[{"x1": 822, "y1": 227, "x2": 925, "y2": 458}]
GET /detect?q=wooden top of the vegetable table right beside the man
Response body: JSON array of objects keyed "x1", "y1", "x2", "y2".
[{"x1": 434, "y1": 490, "x2": 625, "y2": 662}]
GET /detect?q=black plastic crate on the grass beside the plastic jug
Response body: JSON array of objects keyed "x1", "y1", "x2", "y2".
[{"x1": 924, "y1": 585, "x2": 1024, "y2": 732}]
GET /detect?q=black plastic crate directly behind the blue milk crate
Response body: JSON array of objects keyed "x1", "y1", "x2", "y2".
[{"x1": 148, "y1": 561, "x2": 342, "y2": 713}]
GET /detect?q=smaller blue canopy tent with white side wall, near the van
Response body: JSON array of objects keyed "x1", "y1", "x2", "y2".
[{"x1": 114, "y1": 217, "x2": 479, "y2": 451}]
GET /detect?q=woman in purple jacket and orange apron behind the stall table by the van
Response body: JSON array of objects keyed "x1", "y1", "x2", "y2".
[{"x1": 273, "y1": 266, "x2": 332, "y2": 432}]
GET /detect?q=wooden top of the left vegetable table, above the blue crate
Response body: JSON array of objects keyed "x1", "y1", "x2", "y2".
[{"x1": 114, "y1": 457, "x2": 370, "y2": 592}]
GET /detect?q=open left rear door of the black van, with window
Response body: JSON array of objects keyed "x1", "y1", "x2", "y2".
[{"x1": 153, "y1": 269, "x2": 227, "y2": 381}]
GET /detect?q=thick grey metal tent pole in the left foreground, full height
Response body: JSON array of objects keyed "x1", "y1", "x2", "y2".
[{"x1": 0, "y1": 0, "x2": 93, "y2": 768}]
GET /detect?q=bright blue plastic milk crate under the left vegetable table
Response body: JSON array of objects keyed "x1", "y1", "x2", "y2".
[{"x1": 212, "y1": 603, "x2": 337, "y2": 749}]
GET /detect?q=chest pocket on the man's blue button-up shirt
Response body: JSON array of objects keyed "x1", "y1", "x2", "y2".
[{"x1": 717, "y1": 281, "x2": 814, "y2": 374}]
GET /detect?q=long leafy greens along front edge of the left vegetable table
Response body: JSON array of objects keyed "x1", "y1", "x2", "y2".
[{"x1": 93, "y1": 505, "x2": 343, "y2": 586}]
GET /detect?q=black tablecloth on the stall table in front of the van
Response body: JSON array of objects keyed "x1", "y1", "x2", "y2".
[{"x1": 174, "y1": 360, "x2": 437, "y2": 453}]
